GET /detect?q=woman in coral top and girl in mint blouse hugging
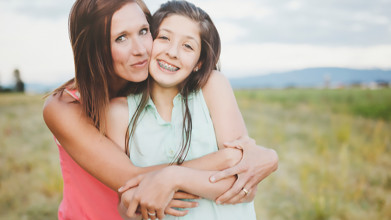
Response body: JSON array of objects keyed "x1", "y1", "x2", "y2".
[{"x1": 43, "y1": 0, "x2": 278, "y2": 220}]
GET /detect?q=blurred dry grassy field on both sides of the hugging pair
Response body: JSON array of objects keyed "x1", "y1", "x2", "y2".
[{"x1": 0, "y1": 89, "x2": 391, "y2": 220}]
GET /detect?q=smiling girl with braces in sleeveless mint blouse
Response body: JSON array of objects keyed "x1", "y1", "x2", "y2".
[{"x1": 107, "y1": 1, "x2": 276, "y2": 219}]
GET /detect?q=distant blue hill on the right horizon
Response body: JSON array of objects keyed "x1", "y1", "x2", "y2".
[{"x1": 230, "y1": 68, "x2": 391, "y2": 88}]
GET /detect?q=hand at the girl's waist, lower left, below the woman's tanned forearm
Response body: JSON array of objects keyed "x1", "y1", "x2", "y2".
[{"x1": 118, "y1": 166, "x2": 196, "y2": 220}]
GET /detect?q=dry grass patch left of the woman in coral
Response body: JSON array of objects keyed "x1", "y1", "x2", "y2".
[{"x1": 0, "y1": 94, "x2": 62, "y2": 220}]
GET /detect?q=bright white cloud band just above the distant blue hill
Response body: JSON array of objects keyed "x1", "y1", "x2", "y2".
[{"x1": 221, "y1": 44, "x2": 391, "y2": 77}]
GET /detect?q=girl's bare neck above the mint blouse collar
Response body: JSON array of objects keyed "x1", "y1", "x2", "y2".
[{"x1": 151, "y1": 81, "x2": 179, "y2": 122}]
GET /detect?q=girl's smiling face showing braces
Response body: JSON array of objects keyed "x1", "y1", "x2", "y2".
[{"x1": 149, "y1": 15, "x2": 201, "y2": 88}]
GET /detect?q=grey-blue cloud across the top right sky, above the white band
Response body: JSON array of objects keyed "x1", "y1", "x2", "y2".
[{"x1": 210, "y1": 0, "x2": 391, "y2": 46}]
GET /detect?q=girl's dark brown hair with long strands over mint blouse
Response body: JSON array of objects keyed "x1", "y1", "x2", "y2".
[{"x1": 126, "y1": 1, "x2": 221, "y2": 164}]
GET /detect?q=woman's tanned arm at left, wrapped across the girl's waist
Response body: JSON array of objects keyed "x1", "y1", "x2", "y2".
[{"x1": 43, "y1": 93, "x2": 241, "y2": 190}]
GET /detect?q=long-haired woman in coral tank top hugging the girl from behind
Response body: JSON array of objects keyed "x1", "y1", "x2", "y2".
[{"x1": 43, "y1": 0, "x2": 276, "y2": 219}]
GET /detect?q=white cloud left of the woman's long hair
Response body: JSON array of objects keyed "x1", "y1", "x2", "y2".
[{"x1": 0, "y1": 11, "x2": 73, "y2": 84}]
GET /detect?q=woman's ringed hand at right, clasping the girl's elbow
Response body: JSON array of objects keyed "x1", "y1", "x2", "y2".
[{"x1": 210, "y1": 136, "x2": 278, "y2": 204}]
